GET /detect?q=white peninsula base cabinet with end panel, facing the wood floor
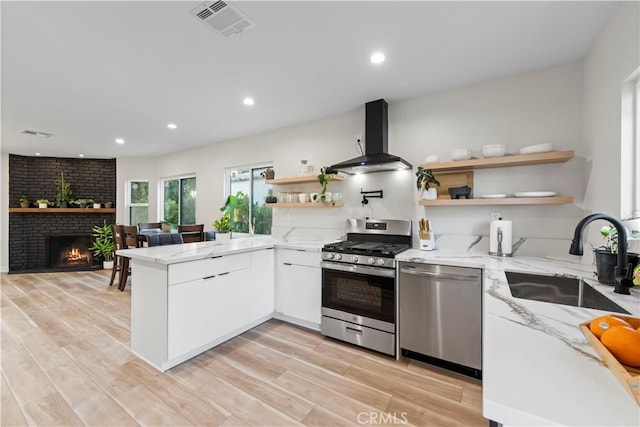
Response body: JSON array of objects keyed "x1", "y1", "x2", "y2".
[{"x1": 131, "y1": 249, "x2": 274, "y2": 371}]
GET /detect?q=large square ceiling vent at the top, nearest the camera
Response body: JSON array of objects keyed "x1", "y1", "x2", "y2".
[{"x1": 189, "y1": 1, "x2": 256, "y2": 37}]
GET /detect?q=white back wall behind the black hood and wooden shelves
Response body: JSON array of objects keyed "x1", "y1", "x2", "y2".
[{"x1": 118, "y1": 63, "x2": 584, "y2": 254}]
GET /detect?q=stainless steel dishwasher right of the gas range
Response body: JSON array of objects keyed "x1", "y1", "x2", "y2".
[{"x1": 398, "y1": 262, "x2": 482, "y2": 377}]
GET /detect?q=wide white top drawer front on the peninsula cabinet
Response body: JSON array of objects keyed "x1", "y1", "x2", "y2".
[{"x1": 168, "y1": 253, "x2": 251, "y2": 286}]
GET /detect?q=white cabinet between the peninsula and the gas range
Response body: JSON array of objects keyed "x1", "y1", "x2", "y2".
[{"x1": 276, "y1": 249, "x2": 322, "y2": 330}]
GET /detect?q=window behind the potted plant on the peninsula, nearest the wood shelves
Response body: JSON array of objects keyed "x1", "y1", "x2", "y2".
[{"x1": 227, "y1": 166, "x2": 273, "y2": 234}]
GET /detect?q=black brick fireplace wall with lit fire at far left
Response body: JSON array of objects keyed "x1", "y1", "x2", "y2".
[{"x1": 9, "y1": 154, "x2": 116, "y2": 273}]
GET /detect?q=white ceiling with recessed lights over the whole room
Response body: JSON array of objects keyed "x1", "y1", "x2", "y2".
[{"x1": 1, "y1": 1, "x2": 618, "y2": 157}]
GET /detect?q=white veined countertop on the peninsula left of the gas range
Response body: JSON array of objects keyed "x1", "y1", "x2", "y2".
[{"x1": 117, "y1": 236, "x2": 327, "y2": 265}]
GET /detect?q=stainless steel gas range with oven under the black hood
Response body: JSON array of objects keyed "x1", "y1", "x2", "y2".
[{"x1": 320, "y1": 219, "x2": 411, "y2": 356}]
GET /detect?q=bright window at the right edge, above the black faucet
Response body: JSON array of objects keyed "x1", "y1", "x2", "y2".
[{"x1": 620, "y1": 68, "x2": 640, "y2": 218}]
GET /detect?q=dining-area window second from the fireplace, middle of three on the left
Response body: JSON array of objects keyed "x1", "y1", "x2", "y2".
[{"x1": 160, "y1": 176, "x2": 196, "y2": 226}]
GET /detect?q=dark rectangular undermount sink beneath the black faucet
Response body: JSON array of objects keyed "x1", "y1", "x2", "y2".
[{"x1": 505, "y1": 271, "x2": 630, "y2": 314}]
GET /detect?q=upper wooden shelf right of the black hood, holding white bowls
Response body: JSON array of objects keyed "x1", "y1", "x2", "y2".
[{"x1": 420, "y1": 150, "x2": 574, "y2": 172}]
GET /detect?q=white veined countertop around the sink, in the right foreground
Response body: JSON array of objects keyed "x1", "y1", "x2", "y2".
[{"x1": 398, "y1": 250, "x2": 640, "y2": 426}]
